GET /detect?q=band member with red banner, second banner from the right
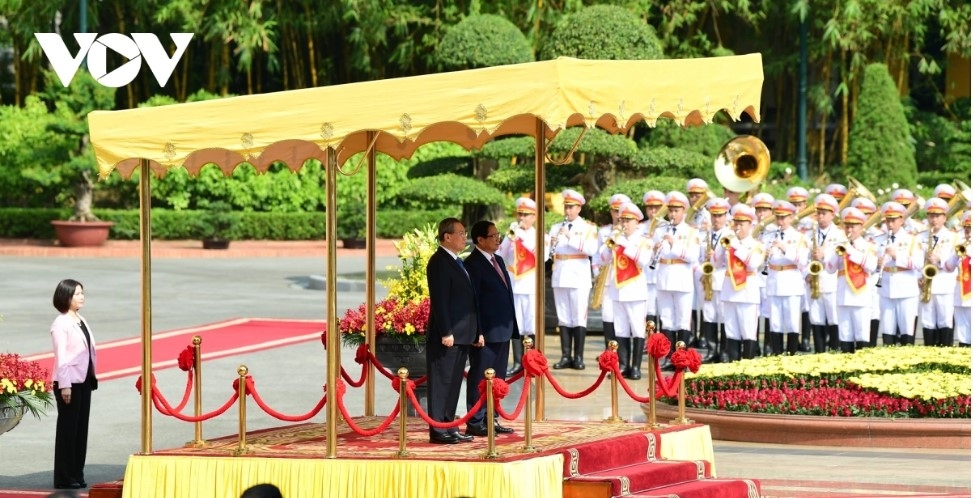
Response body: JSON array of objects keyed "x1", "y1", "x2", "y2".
[{"x1": 824, "y1": 207, "x2": 878, "y2": 353}]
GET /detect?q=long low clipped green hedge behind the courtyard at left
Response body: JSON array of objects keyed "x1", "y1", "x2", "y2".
[{"x1": 0, "y1": 208, "x2": 460, "y2": 240}]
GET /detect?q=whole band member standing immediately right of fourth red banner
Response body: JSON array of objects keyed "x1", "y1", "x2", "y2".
[{"x1": 876, "y1": 201, "x2": 923, "y2": 345}]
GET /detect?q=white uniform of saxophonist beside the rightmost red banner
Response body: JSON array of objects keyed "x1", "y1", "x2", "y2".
[{"x1": 918, "y1": 227, "x2": 956, "y2": 329}]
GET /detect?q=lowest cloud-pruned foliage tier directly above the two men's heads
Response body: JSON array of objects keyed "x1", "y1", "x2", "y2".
[{"x1": 399, "y1": 174, "x2": 505, "y2": 207}]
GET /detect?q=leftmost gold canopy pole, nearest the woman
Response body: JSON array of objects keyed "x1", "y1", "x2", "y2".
[{"x1": 139, "y1": 159, "x2": 152, "y2": 455}]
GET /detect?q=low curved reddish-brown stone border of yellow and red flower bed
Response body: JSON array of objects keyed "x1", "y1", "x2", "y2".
[{"x1": 641, "y1": 403, "x2": 970, "y2": 449}]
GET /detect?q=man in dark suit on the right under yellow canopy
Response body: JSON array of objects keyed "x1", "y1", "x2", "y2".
[{"x1": 464, "y1": 221, "x2": 520, "y2": 436}]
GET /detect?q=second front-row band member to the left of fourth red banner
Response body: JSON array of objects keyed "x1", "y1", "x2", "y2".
[{"x1": 764, "y1": 200, "x2": 808, "y2": 356}]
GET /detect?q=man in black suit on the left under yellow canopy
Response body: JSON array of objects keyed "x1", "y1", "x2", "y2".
[{"x1": 426, "y1": 218, "x2": 477, "y2": 444}]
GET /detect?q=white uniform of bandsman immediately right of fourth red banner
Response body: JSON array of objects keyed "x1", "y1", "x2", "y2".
[{"x1": 876, "y1": 228, "x2": 923, "y2": 337}]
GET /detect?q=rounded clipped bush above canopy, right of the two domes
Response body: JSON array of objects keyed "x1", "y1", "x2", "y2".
[{"x1": 543, "y1": 5, "x2": 665, "y2": 60}]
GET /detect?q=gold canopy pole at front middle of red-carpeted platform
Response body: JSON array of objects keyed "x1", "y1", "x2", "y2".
[{"x1": 324, "y1": 147, "x2": 341, "y2": 458}]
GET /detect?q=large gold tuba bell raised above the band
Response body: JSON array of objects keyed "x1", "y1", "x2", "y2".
[{"x1": 713, "y1": 135, "x2": 770, "y2": 194}]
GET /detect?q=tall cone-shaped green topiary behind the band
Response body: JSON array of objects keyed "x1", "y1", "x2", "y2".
[{"x1": 845, "y1": 64, "x2": 917, "y2": 186}]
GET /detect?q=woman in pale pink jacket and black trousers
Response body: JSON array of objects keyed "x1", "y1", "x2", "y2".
[{"x1": 51, "y1": 279, "x2": 98, "y2": 489}]
